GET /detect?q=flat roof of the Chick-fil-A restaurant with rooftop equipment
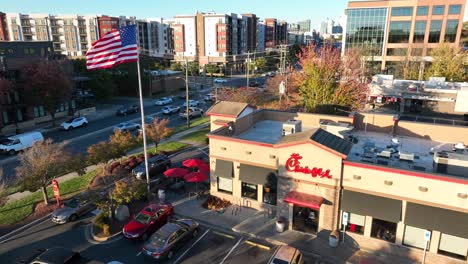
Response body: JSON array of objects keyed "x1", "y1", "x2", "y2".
[{"x1": 211, "y1": 104, "x2": 468, "y2": 179}]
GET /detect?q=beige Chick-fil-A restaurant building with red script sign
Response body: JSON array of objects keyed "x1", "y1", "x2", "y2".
[{"x1": 207, "y1": 102, "x2": 468, "y2": 263}]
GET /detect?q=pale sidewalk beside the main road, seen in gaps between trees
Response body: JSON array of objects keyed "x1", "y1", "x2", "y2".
[{"x1": 7, "y1": 123, "x2": 209, "y2": 202}]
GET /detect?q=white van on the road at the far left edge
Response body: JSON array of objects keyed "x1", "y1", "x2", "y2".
[{"x1": 0, "y1": 132, "x2": 44, "y2": 155}]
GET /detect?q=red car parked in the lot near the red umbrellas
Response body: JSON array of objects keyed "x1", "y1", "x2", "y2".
[{"x1": 122, "y1": 204, "x2": 174, "y2": 241}]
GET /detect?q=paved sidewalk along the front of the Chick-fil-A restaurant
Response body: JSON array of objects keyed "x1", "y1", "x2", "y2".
[{"x1": 172, "y1": 196, "x2": 466, "y2": 264}]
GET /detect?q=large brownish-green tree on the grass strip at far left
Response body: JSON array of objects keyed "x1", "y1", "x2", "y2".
[{"x1": 16, "y1": 139, "x2": 76, "y2": 204}]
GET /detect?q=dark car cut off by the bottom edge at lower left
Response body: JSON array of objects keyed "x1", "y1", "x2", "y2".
[{"x1": 25, "y1": 247, "x2": 81, "y2": 264}]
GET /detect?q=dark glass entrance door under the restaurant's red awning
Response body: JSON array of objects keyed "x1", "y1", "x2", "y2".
[{"x1": 293, "y1": 205, "x2": 319, "y2": 234}]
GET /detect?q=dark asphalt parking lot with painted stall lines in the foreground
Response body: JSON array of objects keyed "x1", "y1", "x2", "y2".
[{"x1": 0, "y1": 212, "x2": 328, "y2": 264}]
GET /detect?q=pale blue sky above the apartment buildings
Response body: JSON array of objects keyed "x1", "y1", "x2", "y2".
[{"x1": 0, "y1": 0, "x2": 347, "y2": 29}]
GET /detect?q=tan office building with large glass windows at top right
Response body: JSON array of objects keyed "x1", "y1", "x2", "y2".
[{"x1": 343, "y1": 0, "x2": 466, "y2": 70}]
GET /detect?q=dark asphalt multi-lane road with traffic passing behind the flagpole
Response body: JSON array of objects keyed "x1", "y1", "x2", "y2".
[{"x1": 0, "y1": 92, "x2": 211, "y2": 180}]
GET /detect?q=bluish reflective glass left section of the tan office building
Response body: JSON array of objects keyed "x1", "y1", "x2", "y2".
[{"x1": 346, "y1": 8, "x2": 387, "y2": 56}]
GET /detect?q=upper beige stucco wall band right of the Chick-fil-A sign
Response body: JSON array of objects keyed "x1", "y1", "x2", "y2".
[{"x1": 343, "y1": 162, "x2": 468, "y2": 213}]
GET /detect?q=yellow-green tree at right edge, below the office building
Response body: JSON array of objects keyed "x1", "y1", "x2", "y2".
[{"x1": 425, "y1": 43, "x2": 468, "y2": 82}]
